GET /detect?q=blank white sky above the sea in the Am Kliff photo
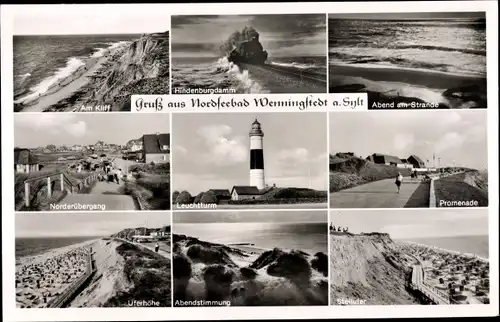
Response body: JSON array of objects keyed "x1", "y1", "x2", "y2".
[{"x1": 13, "y1": 4, "x2": 170, "y2": 35}]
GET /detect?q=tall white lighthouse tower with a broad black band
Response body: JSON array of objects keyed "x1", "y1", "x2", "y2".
[{"x1": 250, "y1": 119, "x2": 266, "y2": 189}]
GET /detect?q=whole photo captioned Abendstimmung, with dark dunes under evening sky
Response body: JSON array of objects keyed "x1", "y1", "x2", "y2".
[{"x1": 173, "y1": 210, "x2": 328, "y2": 307}]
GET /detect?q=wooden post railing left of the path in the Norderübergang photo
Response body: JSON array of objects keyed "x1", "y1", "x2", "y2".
[{"x1": 24, "y1": 171, "x2": 97, "y2": 207}]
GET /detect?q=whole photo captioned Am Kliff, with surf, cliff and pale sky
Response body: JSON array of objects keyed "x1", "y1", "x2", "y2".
[{"x1": 13, "y1": 6, "x2": 170, "y2": 112}]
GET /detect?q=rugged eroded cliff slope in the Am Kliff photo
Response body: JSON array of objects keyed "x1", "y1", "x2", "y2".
[{"x1": 81, "y1": 32, "x2": 170, "y2": 110}]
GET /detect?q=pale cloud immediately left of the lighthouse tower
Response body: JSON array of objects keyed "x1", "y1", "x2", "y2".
[{"x1": 197, "y1": 125, "x2": 248, "y2": 166}]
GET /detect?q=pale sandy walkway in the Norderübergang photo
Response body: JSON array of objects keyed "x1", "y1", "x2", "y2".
[{"x1": 56, "y1": 158, "x2": 137, "y2": 211}]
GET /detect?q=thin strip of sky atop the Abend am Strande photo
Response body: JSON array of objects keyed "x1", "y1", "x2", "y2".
[{"x1": 328, "y1": 12, "x2": 486, "y2": 20}]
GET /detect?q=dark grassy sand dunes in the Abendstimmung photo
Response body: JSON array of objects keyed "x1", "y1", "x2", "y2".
[{"x1": 173, "y1": 234, "x2": 328, "y2": 306}]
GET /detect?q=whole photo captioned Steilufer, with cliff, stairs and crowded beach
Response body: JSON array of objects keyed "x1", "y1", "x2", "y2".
[{"x1": 329, "y1": 208, "x2": 490, "y2": 305}]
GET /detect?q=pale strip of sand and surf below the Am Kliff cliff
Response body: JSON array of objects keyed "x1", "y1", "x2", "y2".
[{"x1": 14, "y1": 42, "x2": 128, "y2": 112}]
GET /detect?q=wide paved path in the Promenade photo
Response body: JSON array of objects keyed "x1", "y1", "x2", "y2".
[{"x1": 330, "y1": 178, "x2": 420, "y2": 208}]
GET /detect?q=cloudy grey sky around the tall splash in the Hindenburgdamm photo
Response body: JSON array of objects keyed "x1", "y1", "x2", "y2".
[{"x1": 172, "y1": 14, "x2": 326, "y2": 58}]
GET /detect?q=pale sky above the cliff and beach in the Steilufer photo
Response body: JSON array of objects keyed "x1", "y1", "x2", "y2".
[{"x1": 330, "y1": 208, "x2": 488, "y2": 240}]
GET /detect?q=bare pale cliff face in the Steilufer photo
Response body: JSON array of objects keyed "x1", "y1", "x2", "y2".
[{"x1": 330, "y1": 233, "x2": 415, "y2": 305}]
